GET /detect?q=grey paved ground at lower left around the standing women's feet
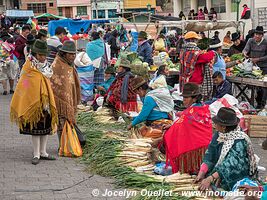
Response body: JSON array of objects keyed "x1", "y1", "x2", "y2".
[{"x1": 0, "y1": 93, "x2": 123, "y2": 200}]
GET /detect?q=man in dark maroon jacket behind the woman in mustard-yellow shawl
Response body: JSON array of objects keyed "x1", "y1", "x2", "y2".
[{"x1": 15, "y1": 26, "x2": 31, "y2": 69}]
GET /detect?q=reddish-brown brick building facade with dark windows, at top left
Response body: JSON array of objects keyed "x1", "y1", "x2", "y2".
[{"x1": 20, "y1": 0, "x2": 58, "y2": 15}]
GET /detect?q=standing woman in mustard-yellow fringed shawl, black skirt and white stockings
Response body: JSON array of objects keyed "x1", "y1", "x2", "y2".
[{"x1": 10, "y1": 40, "x2": 58, "y2": 165}]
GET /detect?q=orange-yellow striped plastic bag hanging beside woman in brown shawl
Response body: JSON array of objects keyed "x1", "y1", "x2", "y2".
[{"x1": 59, "y1": 121, "x2": 83, "y2": 157}]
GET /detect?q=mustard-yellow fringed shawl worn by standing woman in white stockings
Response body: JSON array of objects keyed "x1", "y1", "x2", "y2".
[{"x1": 10, "y1": 59, "x2": 58, "y2": 129}]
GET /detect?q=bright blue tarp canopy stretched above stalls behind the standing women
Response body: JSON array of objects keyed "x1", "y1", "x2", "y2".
[{"x1": 48, "y1": 19, "x2": 110, "y2": 36}]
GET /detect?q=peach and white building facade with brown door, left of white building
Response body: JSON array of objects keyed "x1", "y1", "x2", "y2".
[{"x1": 57, "y1": 0, "x2": 91, "y2": 19}]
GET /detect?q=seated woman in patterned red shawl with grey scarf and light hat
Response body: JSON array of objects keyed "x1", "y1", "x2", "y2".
[{"x1": 107, "y1": 59, "x2": 137, "y2": 112}]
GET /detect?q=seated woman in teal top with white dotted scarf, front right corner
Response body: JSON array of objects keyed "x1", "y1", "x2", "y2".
[{"x1": 196, "y1": 108, "x2": 257, "y2": 190}]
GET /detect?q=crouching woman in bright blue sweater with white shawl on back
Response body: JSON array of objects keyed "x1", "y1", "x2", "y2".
[{"x1": 128, "y1": 77, "x2": 174, "y2": 139}]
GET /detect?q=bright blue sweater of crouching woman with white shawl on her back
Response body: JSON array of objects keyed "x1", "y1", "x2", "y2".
[{"x1": 132, "y1": 96, "x2": 169, "y2": 126}]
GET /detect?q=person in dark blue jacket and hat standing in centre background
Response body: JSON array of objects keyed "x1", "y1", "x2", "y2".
[{"x1": 137, "y1": 31, "x2": 153, "y2": 65}]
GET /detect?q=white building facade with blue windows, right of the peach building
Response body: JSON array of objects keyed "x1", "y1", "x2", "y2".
[{"x1": 92, "y1": 0, "x2": 123, "y2": 19}]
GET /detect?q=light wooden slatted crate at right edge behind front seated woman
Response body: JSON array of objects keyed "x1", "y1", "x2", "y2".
[{"x1": 244, "y1": 115, "x2": 267, "y2": 138}]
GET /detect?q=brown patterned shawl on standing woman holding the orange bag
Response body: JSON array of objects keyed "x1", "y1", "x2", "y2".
[{"x1": 51, "y1": 55, "x2": 81, "y2": 123}]
